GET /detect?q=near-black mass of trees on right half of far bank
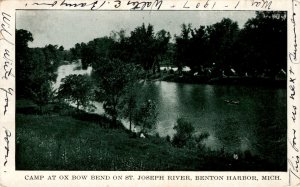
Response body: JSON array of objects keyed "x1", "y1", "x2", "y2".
[{"x1": 174, "y1": 12, "x2": 287, "y2": 78}]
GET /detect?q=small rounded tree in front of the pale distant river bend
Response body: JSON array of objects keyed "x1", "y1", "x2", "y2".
[{"x1": 57, "y1": 75, "x2": 94, "y2": 111}]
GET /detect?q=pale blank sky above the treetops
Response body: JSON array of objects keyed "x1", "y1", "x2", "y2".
[{"x1": 16, "y1": 10, "x2": 255, "y2": 49}]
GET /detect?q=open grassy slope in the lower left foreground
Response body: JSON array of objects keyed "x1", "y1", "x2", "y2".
[{"x1": 16, "y1": 114, "x2": 199, "y2": 170}]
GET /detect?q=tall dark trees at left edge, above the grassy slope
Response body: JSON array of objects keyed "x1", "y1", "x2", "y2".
[{"x1": 16, "y1": 30, "x2": 62, "y2": 112}]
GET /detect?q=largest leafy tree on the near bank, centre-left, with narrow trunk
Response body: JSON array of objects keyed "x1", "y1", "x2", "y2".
[{"x1": 92, "y1": 58, "x2": 140, "y2": 127}]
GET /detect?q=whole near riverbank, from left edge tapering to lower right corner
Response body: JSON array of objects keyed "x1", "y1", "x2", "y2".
[{"x1": 16, "y1": 101, "x2": 286, "y2": 171}]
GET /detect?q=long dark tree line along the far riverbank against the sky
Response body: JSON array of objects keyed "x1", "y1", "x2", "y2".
[{"x1": 67, "y1": 11, "x2": 287, "y2": 78}]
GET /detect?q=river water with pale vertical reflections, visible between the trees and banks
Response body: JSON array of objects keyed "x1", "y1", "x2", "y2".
[{"x1": 54, "y1": 61, "x2": 287, "y2": 160}]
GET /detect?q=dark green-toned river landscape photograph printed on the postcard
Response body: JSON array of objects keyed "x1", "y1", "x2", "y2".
[{"x1": 15, "y1": 10, "x2": 289, "y2": 172}]
